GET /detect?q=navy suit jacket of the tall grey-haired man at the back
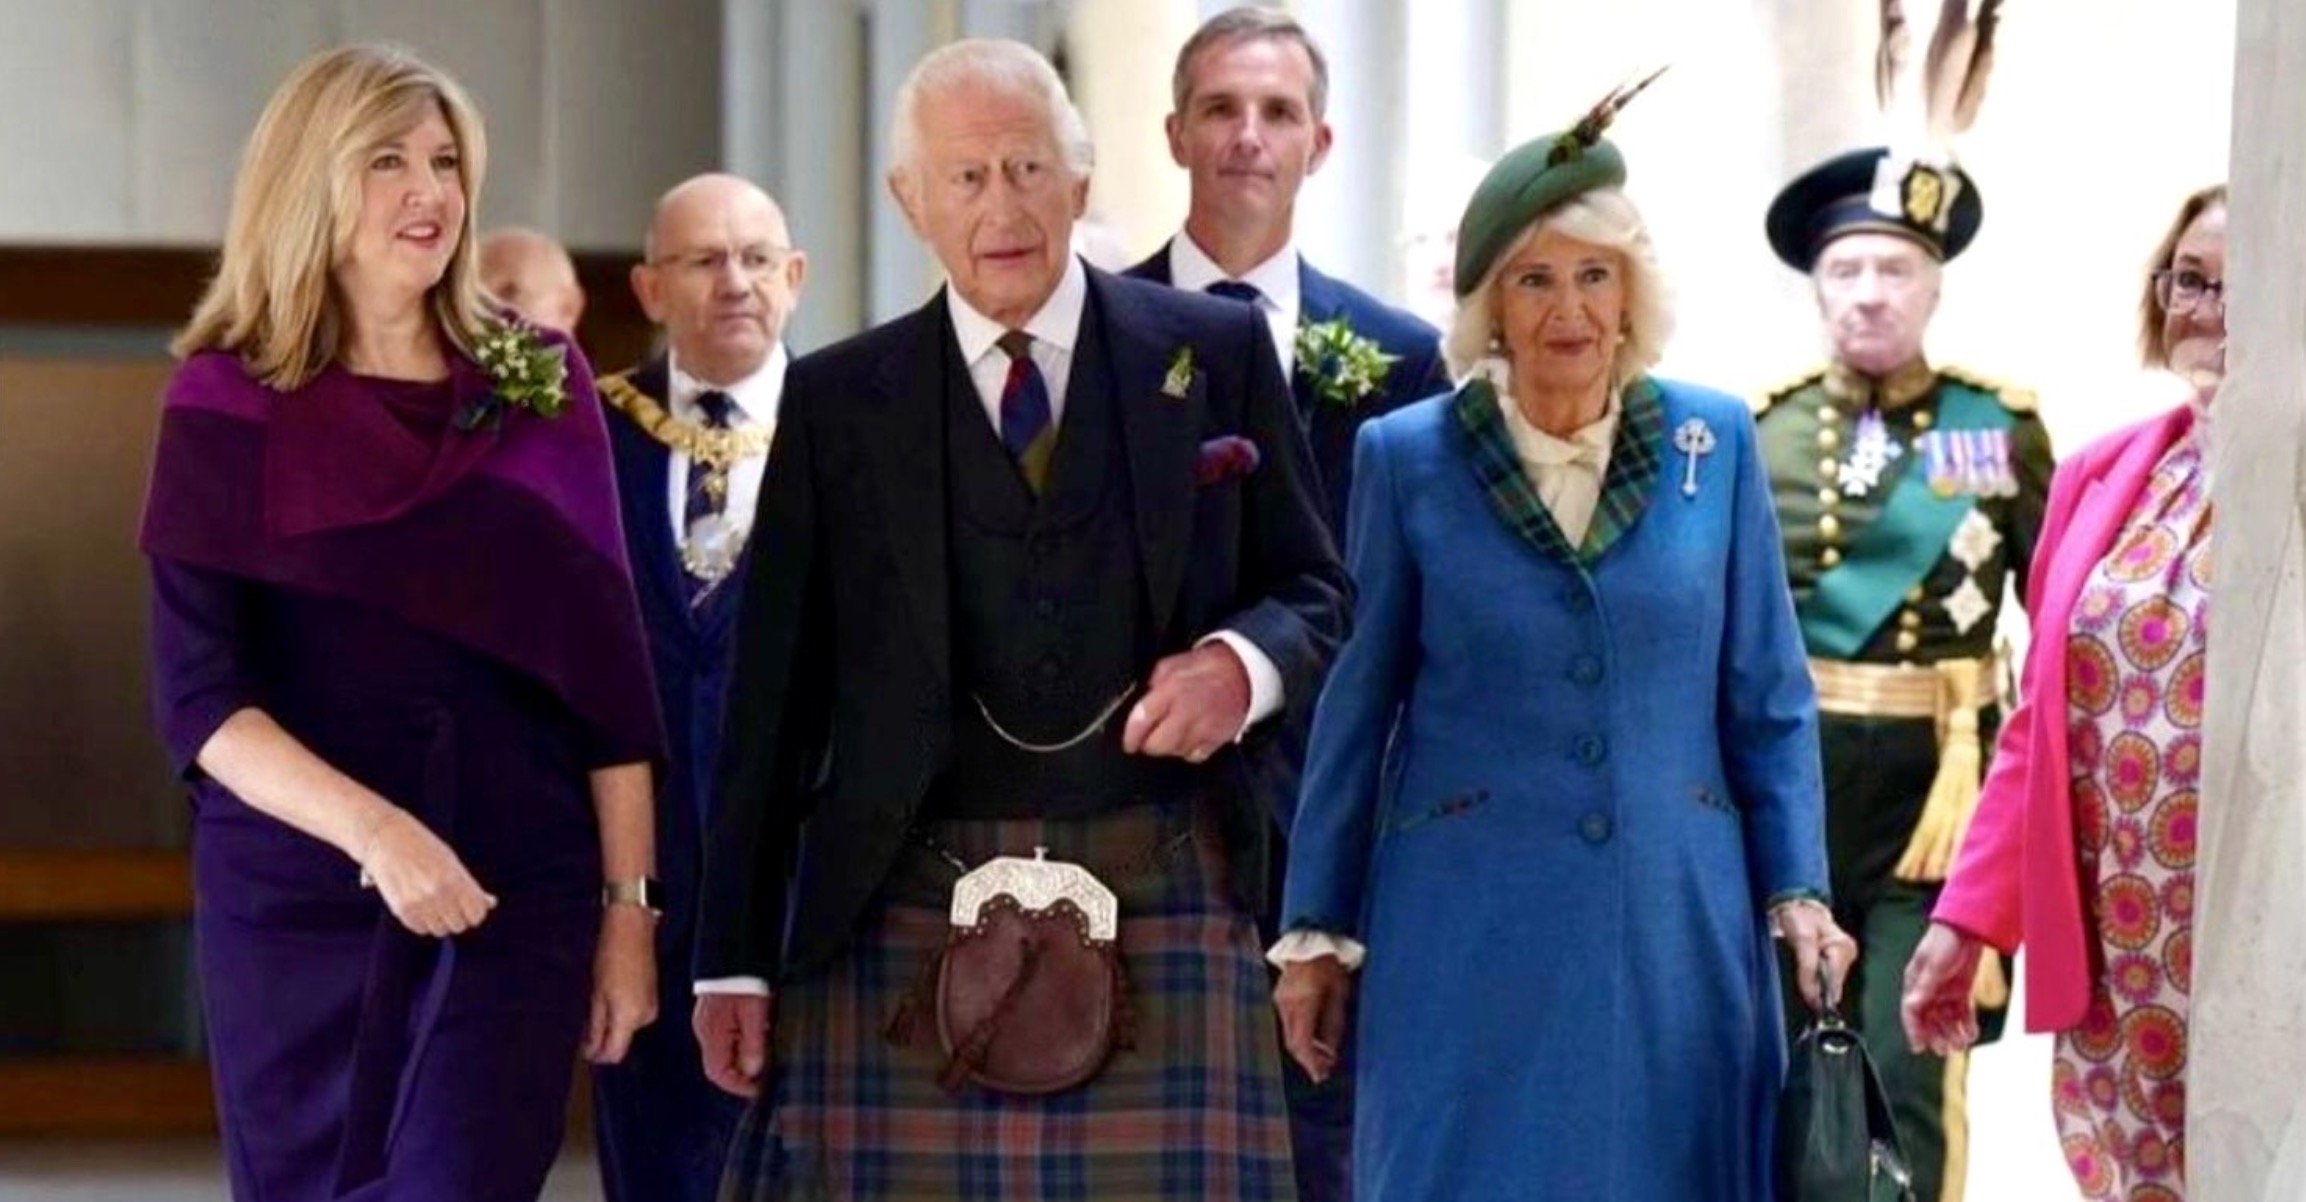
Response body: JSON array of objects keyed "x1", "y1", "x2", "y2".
[{"x1": 1128, "y1": 245, "x2": 1450, "y2": 532}]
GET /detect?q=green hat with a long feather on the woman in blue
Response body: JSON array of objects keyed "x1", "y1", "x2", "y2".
[{"x1": 1450, "y1": 67, "x2": 1665, "y2": 300}]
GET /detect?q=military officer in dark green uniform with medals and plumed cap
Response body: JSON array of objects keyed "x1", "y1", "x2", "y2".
[{"x1": 1757, "y1": 148, "x2": 2050, "y2": 1202}]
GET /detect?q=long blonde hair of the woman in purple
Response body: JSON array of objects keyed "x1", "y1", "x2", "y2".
[{"x1": 168, "y1": 46, "x2": 489, "y2": 390}]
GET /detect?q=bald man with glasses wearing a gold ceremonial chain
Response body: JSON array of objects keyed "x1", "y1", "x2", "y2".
[{"x1": 593, "y1": 175, "x2": 807, "y2": 1202}]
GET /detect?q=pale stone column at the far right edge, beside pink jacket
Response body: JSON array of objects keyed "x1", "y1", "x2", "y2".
[{"x1": 2186, "y1": 0, "x2": 2306, "y2": 1202}]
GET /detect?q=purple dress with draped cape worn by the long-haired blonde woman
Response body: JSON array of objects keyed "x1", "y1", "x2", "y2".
[{"x1": 143, "y1": 343, "x2": 662, "y2": 1202}]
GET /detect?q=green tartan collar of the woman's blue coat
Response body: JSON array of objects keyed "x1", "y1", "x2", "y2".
[{"x1": 1450, "y1": 376, "x2": 1665, "y2": 568}]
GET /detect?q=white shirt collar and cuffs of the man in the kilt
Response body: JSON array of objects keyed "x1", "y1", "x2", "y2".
[{"x1": 696, "y1": 258, "x2": 1284, "y2": 997}]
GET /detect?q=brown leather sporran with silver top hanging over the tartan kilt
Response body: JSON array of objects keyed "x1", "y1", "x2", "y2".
[{"x1": 890, "y1": 849, "x2": 1135, "y2": 1094}]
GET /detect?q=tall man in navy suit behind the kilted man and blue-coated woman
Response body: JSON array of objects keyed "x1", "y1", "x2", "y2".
[{"x1": 1130, "y1": 16, "x2": 1450, "y2": 1202}]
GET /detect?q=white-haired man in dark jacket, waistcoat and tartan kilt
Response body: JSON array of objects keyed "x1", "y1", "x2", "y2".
[{"x1": 694, "y1": 42, "x2": 1349, "y2": 1202}]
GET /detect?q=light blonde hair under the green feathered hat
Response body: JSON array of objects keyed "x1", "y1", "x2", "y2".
[{"x1": 1441, "y1": 187, "x2": 1674, "y2": 390}]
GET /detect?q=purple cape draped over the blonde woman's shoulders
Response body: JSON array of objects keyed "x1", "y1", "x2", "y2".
[{"x1": 138, "y1": 335, "x2": 664, "y2": 764}]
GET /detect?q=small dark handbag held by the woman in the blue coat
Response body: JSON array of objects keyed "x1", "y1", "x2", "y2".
[{"x1": 1778, "y1": 992, "x2": 1914, "y2": 1202}]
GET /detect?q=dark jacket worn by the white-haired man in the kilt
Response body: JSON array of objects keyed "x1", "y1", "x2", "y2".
[{"x1": 696, "y1": 270, "x2": 1351, "y2": 981}]
